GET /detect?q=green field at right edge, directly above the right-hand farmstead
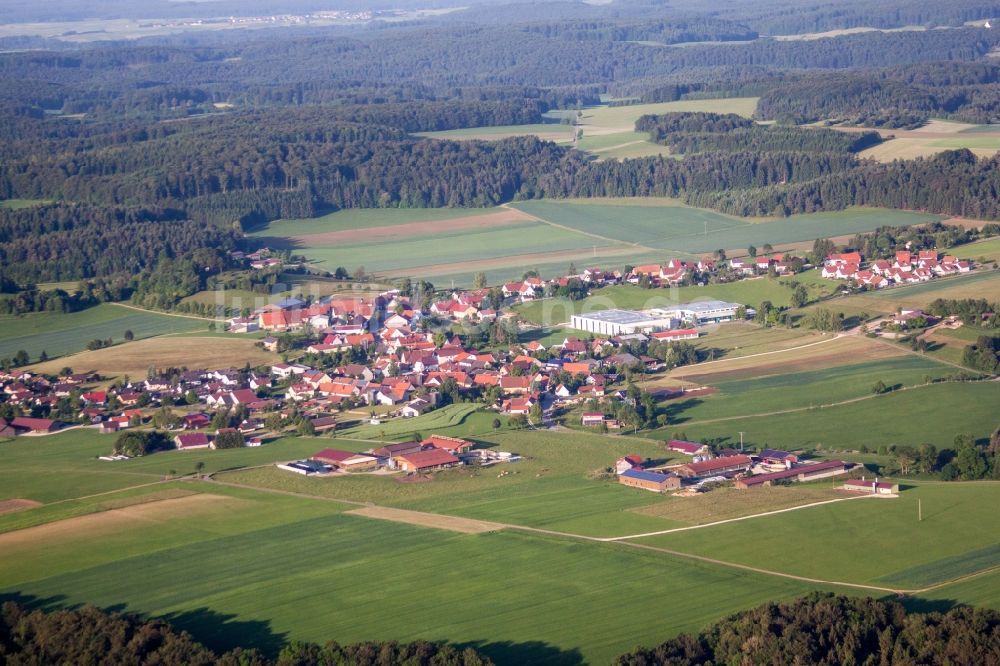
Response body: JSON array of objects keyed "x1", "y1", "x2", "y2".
[{"x1": 667, "y1": 382, "x2": 1000, "y2": 450}]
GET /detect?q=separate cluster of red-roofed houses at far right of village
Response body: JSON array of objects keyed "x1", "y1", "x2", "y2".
[{"x1": 822, "y1": 250, "x2": 972, "y2": 289}]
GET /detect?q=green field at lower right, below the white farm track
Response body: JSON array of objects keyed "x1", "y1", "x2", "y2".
[{"x1": 643, "y1": 482, "x2": 1000, "y2": 588}]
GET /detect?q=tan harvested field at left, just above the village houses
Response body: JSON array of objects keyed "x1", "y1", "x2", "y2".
[{"x1": 32, "y1": 337, "x2": 278, "y2": 377}]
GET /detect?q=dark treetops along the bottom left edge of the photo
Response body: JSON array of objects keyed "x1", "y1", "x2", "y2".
[{"x1": 0, "y1": 602, "x2": 493, "y2": 666}]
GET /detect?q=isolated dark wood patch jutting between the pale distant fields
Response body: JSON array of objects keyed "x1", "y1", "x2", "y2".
[{"x1": 635, "y1": 113, "x2": 882, "y2": 154}]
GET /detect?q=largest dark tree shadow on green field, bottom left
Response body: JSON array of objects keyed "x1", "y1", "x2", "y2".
[{"x1": 163, "y1": 608, "x2": 287, "y2": 659}]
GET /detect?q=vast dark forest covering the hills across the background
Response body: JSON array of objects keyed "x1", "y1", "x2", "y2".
[{"x1": 0, "y1": 0, "x2": 1000, "y2": 298}]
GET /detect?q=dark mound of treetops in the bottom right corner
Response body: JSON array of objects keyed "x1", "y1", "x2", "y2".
[{"x1": 613, "y1": 593, "x2": 1000, "y2": 666}]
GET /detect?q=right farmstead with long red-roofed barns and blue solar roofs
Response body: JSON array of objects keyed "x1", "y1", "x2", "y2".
[{"x1": 615, "y1": 440, "x2": 872, "y2": 494}]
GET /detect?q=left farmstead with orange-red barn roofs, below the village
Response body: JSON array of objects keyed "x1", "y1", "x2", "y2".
[{"x1": 277, "y1": 435, "x2": 520, "y2": 476}]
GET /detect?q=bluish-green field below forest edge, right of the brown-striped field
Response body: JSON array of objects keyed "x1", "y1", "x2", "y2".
[{"x1": 514, "y1": 199, "x2": 940, "y2": 254}]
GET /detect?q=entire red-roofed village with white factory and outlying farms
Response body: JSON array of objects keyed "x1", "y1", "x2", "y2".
[{"x1": 0, "y1": 244, "x2": 972, "y2": 494}]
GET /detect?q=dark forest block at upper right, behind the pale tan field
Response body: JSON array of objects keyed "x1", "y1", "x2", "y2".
[{"x1": 757, "y1": 62, "x2": 1000, "y2": 128}]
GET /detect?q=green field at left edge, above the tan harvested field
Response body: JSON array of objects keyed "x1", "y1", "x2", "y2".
[{"x1": 0, "y1": 304, "x2": 208, "y2": 360}]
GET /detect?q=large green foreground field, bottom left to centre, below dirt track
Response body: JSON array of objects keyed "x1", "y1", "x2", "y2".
[{"x1": 0, "y1": 486, "x2": 810, "y2": 664}]
